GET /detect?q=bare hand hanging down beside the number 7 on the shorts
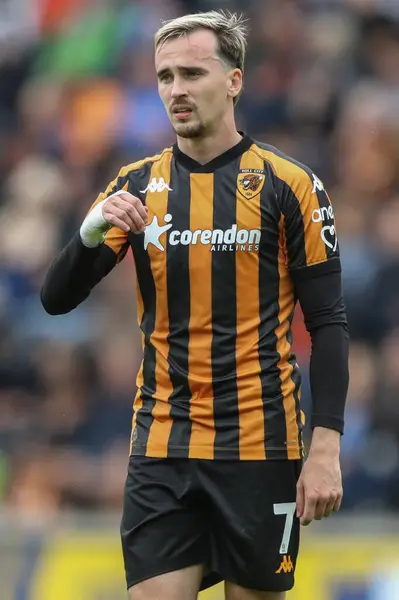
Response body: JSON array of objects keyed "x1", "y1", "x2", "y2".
[{"x1": 297, "y1": 427, "x2": 343, "y2": 525}]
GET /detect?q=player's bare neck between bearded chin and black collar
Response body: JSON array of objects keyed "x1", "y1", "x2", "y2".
[{"x1": 177, "y1": 120, "x2": 242, "y2": 165}]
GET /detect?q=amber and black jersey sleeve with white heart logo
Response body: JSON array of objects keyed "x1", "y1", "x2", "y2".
[{"x1": 279, "y1": 163, "x2": 341, "y2": 280}]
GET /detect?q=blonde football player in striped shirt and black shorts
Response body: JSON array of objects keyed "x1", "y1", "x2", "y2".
[{"x1": 41, "y1": 11, "x2": 348, "y2": 600}]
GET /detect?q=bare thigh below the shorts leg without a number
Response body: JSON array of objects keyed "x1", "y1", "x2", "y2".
[{"x1": 128, "y1": 565, "x2": 204, "y2": 600}]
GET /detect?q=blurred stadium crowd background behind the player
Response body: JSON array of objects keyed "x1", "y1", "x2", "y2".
[{"x1": 0, "y1": 0, "x2": 399, "y2": 600}]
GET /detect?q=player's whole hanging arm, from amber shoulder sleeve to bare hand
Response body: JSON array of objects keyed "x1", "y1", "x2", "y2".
[{"x1": 276, "y1": 161, "x2": 349, "y2": 525}]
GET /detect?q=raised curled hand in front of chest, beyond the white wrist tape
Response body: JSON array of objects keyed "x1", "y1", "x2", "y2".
[{"x1": 102, "y1": 191, "x2": 148, "y2": 233}]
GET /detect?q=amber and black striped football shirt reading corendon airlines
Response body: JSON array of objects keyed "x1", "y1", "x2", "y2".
[{"x1": 70, "y1": 136, "x2": 339, "y2": 460}]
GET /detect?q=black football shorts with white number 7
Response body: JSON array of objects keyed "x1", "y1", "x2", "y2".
[{"x1": 121, "y1": 456, "x2": 301, "y2": 591}]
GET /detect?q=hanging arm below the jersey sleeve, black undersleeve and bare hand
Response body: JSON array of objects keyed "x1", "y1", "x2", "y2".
[{"x1": 296, "y1": 272, "x2": 349, "y2": 525}]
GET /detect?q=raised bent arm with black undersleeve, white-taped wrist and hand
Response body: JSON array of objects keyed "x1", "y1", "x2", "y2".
[{"x1": 40, "y1": 173, "x2": 147, "y2": 315}]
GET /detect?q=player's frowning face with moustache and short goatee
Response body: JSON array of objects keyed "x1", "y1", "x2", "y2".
[{"x1": 155, "y1": 29, "x2": 241, "y2": 138}]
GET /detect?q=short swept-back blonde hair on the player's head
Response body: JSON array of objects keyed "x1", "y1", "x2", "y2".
[{"x1": 154, "y1": 10, "x2": 247, "y2": 72}]
